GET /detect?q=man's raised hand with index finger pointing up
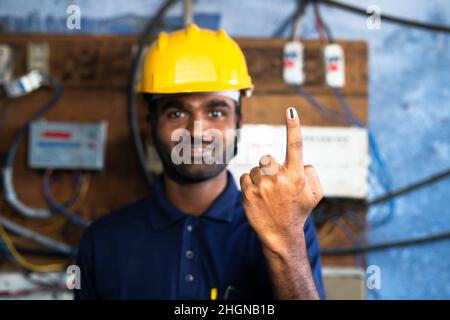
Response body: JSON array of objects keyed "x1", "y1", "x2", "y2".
[{"x1": 240, "y1": 108, "x2": 323, "y2": 253}]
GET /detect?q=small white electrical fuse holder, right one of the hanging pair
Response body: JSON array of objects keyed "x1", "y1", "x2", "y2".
[{"x1": 323, "y1": 43, "x2": 345, "y2": 88}]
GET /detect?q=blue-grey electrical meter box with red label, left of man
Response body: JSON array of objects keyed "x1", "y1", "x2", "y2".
[{"x1": 28, "y1": 121, "x2": 107, "y2": 170}]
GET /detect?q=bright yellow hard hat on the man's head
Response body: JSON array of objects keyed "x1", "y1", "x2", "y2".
[{"x1": 138, "y1": 24, "x2": 253, "y2": 95}]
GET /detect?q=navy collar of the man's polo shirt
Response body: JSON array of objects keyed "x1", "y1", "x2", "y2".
[{"x1": 150, "y1": 171, "x2": 239, "y2": 229}]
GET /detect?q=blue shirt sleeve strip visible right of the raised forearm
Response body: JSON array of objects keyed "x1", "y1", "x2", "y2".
[{"x1": 303, "y1": 215, "x2": 325, "y2": 300}]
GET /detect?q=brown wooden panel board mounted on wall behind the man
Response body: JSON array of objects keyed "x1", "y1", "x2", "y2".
[{"x1": 0, "y1": 34, "x2": 367, "y2": 265}]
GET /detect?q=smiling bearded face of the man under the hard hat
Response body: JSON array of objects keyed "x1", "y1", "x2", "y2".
[{"x1": 151, "y1": 93, "x2": 240, "y2": 183}]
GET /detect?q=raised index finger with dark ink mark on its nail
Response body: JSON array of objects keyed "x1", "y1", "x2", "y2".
[{"x1": 286, "y1": 107, "x2": 303, "y2": 172}]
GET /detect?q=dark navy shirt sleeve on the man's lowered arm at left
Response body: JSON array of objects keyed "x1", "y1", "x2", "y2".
[{"x1": 74, "y1": 228, "x2": 101, "y2": 300}]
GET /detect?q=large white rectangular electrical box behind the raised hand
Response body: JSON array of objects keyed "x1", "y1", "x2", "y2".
[{"x1": 229, "y1": 124, "x2": 370, "y2": 199}]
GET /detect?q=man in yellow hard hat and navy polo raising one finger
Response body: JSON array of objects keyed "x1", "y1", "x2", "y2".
[{"x1": 75, "y1": 25, "x2": 324, "y2": 299}]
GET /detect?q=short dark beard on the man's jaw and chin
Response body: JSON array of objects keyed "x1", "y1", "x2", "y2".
[{"x1": 153, "y1": 134, "x2": 238, "y2": 184}]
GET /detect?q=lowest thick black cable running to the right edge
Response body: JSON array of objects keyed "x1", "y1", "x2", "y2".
[{"x1": 321, "y1": 231, "x2": 450, "y2": 256}]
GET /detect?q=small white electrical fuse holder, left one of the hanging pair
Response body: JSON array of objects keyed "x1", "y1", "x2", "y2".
[{"x1": 283, "y1": 41, "x2": 305, "y2": 85}]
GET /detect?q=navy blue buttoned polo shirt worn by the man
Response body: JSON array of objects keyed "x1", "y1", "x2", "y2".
[{"x1": 75, "y1": 173, "x2": 324, "y2": 299}]
